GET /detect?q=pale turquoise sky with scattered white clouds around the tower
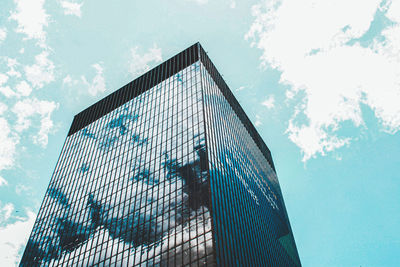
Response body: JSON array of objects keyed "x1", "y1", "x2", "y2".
[{"x1": 0, "y1": 0, "x2": 400, "y2": 267}]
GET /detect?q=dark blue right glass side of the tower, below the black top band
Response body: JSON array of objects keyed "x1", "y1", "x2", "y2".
[{"x1": 202, "y1": 65, "x2": 300, "y2": 266}]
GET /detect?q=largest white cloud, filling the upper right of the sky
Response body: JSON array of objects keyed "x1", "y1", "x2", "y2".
[{"x1": 246, "y1": 0, "x2": 400, "y2": 161}]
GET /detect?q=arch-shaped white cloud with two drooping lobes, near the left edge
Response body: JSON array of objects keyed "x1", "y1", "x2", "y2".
[{"x1": 12, "y1": 98, "x2": 58, "y2": 147}]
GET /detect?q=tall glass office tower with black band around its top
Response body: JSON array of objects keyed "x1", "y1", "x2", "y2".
[{"x1": 20, "y1": 43, "x2": 300, "y2": 266}]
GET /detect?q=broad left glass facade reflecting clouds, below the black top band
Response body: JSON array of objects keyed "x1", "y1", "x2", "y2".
[{"x1": 21, "y1": 62, "x2": 214, "y2": 266}]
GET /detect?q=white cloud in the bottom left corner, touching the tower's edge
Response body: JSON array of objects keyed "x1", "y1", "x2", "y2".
[{"x1": 0, "y1": 211, "x2": 36, "y2": 266}]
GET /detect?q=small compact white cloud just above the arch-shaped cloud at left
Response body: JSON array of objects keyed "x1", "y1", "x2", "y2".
[{"x1": 24, "y1": 51, "x2": 54, "y2": 88}]
